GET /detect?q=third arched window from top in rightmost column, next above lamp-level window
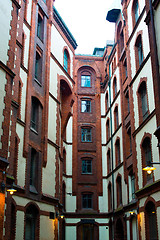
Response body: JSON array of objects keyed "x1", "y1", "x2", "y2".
[{"x1": 138, "y1": 82, "x2": 149, "y2": 121}]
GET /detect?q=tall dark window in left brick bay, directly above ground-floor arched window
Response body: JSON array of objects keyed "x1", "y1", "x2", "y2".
[{"x1": 30, "y1": 148, "x2": 38, "y2": 189}]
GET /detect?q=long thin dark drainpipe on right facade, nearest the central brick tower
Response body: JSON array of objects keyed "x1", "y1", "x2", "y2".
[{"x1": 108, "y1": 74, "x2": 115, "y2": 240}]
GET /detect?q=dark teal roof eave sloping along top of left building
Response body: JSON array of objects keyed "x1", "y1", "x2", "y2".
[{"x1": 53, "y1": 6, "x2": 78, "y2": 50}]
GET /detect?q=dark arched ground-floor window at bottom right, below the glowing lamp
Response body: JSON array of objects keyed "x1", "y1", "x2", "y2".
[{"x1": 145, "y1": 201, "x2": 158, "y2": 240}]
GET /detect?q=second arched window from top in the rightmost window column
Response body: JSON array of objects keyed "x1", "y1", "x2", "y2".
[{"x1": 135, "y1": 34, "x2": 143, "y2": 69}]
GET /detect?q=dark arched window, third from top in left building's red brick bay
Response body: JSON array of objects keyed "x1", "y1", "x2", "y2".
[{"x1": 31, "y1": 97, "x2": 39, "y2": 131}]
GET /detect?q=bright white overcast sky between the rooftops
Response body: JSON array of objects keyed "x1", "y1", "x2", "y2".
[{"x1": 54, "y1": 0, "x2": 115, "y2": 54}]
